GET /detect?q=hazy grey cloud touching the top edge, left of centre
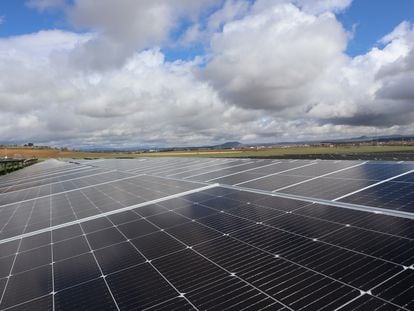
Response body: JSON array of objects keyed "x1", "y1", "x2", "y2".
[{"x1": 66, "y1": 0, "x2": 214, "y2": 70}]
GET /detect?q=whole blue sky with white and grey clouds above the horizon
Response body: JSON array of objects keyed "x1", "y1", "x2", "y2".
[{"x1": 0, "y1": 0, "x2": 414, "y2": 147}]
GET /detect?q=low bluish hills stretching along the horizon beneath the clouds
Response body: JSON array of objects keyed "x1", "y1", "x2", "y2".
[{"x1": 79, "y1": 135, "x2": 414, "y2": 152}]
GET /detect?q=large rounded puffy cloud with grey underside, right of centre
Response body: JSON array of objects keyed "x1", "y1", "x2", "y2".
[{"x1": 204, "y1": 2, "x2": 347, "y2": 111}]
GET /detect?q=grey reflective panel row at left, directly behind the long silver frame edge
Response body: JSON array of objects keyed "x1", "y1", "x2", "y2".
[{"x1": 0, "y1": 177, "x2": 202, "y2": 239}]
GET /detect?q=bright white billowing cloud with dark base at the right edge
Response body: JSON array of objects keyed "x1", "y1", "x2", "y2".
[{"x1": 312, "y1": 21, "x2": 414, "y2": 127}]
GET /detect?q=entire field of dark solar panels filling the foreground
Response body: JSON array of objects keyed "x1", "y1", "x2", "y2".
[{"x1": 0, "y1": 158, "x2": 414, "y2": 311}]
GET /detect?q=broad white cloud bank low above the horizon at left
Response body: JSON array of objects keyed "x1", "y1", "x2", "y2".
[{"x1": 0, "y1": 31, "x2": 252, "y2": 145}]
